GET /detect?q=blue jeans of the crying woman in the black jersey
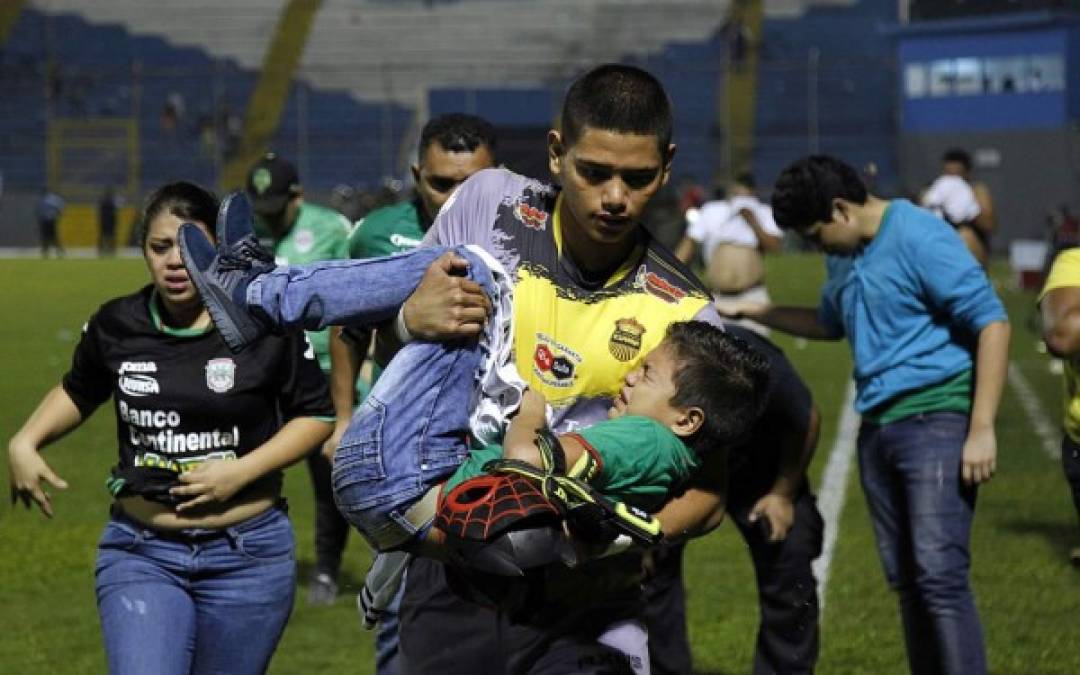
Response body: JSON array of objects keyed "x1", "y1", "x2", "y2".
[{"x1": 96, "y1": 508, "x2": 296, "y2": 675}]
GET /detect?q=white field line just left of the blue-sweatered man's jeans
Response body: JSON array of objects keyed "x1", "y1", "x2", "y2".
[{"x1": 813, "y1": 381, "x2": 860, "y2": 613}]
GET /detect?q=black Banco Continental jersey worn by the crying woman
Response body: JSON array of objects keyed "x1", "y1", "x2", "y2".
[{"x1": 63, "y1": 286, "x2": 334, "y2": 484}]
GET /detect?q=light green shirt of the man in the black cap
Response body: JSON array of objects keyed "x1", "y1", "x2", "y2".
[{"x1": 274, "y1": 202, "x2": 368, "y2": 401}]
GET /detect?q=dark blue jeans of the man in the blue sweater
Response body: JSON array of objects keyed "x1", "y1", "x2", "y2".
[{"x1": 859, "y1": 413, "x2": 986, "y2": 675}]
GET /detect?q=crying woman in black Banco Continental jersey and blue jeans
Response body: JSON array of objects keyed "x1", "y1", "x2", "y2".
[{"x1": 9, "y1": 183, "x2": 334, "y2": 674}]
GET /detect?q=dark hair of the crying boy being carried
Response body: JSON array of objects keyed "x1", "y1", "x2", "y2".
[{"x1": 664, "y1": 321, "x2": 769, "y2": 457}]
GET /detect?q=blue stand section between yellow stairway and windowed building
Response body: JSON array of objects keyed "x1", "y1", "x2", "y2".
[{"x1": 754, "y1": 0, "x2": 899, "y2": 193}]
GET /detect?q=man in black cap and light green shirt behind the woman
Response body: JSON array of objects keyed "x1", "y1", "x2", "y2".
[{"x1": 247, "y1": 152, "x2": 358, "y2": 605}]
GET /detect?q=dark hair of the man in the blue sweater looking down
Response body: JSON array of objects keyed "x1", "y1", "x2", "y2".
[{"x1": 772, "y1": 154, "x2": 868, "y2": 232}]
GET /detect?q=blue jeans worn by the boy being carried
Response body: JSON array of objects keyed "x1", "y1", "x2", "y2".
[{"x1": 247, "y1": 246, "x2": 494, "y2": 551}]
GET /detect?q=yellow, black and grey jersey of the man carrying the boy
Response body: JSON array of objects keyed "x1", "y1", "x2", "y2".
[{"x1": 424, "y1": 168, "x2": 721, "y2": 432}]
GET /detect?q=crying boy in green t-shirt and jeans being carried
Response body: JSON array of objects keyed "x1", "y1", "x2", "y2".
[{"x1": 174, "y1": 195, "x2": 768, "y2": 552}]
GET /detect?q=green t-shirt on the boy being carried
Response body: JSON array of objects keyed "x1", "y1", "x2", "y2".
[{"x1": 444, "y1": 416, "x2": 701, "y2": 513}]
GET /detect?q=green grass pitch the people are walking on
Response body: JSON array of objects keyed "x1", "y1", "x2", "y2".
[{"x1": 0, "y1": 256, "x2": 1080, "y2": 675}]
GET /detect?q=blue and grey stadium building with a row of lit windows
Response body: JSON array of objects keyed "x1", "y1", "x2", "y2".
[{"x1": 896, "y1": 12, "x2": 1080, "y2": 245}]
